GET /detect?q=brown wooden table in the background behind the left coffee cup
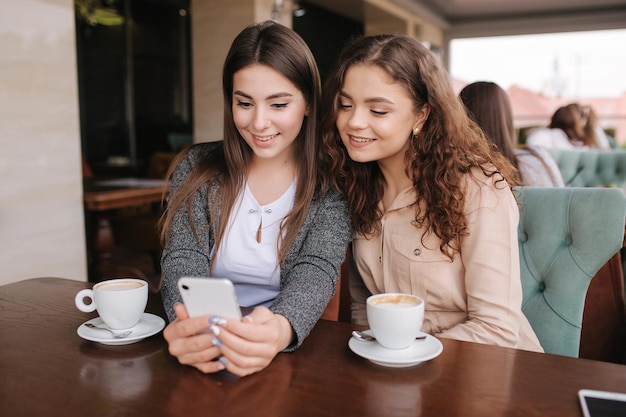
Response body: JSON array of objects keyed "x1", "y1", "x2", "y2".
[{"x1": 83, "y1": 178, "x2": 169, "y2": 281}]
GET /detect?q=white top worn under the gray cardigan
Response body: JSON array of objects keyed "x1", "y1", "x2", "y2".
[{"x1": 213, "y1": 181, "x2": 296, "y2": 307}]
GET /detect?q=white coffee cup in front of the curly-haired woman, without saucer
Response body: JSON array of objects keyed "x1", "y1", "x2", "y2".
[{"x1": 366, "y1": 293, "x2": 424, "y2": 349}]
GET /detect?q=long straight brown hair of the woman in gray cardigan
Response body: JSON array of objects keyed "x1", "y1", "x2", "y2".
[{"x1": 161, "y1": 21, "x2": 328, "y2": 263}]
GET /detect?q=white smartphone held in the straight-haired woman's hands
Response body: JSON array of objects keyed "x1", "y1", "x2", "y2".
[{"x1": 178, "y1": 277, "x2": 241, "y2": 320}]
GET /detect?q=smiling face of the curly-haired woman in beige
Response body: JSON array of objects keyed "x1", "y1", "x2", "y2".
[{"x1": 336, "y1": 64, "x2": 427, "y2": 167}]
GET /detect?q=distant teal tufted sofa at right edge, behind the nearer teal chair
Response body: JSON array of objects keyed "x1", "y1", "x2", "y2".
[{"x1": 548, "y1": 149, "x2": 626, "y2": 187}]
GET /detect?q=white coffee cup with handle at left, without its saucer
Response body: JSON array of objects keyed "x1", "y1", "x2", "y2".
[{"x1": 74, "y1": 278, "x2": 148, "y2": 330}]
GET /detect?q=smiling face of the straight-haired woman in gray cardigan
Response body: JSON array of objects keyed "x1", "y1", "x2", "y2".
[{"x1": 232, "y1": 64, "x2": 307, "y2": 163}]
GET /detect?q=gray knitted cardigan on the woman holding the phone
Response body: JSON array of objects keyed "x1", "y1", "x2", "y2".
[{"x1": 161, "y1": 143, "x2": 351, "y2": 351}]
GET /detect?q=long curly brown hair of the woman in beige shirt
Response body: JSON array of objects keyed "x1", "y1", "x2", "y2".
[{"x1": 322, "y1": 35, "x2": 519, "y2": 257}]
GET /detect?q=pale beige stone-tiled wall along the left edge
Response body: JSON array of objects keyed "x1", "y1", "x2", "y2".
[{"x1": 0, "y1": 0, "x2": 87, "y2": 285}]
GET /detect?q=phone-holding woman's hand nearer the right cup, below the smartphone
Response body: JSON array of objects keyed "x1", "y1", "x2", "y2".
[{"x1": 211, "y1": 307, "x2": 294, "y2": 376}]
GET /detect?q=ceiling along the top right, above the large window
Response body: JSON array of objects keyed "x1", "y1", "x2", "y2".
[{"x1": 309, "y1": 0, "x2": 626, "y2": 39}]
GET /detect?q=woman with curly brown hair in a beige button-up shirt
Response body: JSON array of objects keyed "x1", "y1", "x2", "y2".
[{"x1": 322, "y1": 35, "x2": 543, "y2": 352}]
